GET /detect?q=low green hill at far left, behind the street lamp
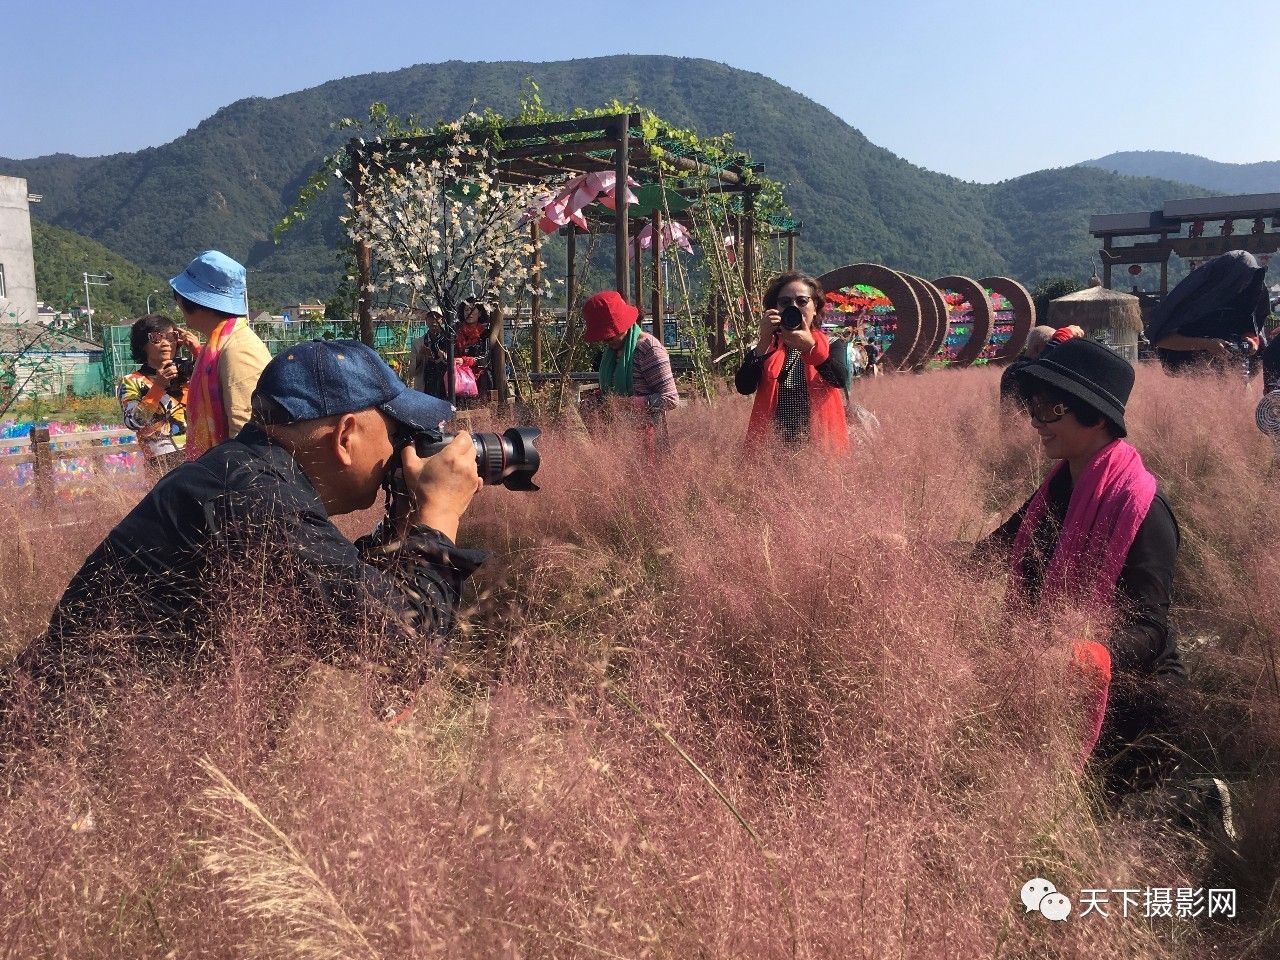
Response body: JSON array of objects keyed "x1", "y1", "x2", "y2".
[{"x1": 31, "y1": 218, "x2": 173, "y2": 323}]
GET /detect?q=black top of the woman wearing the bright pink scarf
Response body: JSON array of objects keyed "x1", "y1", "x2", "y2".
[{"x1": 982, "y1": 470, "x2": 1187, "y2": 676}]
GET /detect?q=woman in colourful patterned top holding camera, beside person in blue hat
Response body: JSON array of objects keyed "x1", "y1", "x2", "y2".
[{"x1": 115, "y1": 314, "x2": 200, "y2": 472}]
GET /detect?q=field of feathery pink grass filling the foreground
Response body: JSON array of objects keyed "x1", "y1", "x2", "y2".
[{"x1": 0, "y1": 366, "x2": 1280, "y2": 957}]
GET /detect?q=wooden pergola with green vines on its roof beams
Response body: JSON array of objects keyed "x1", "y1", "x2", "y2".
[{"x1": 347, "y1": 113, "x2": 800, "y2": 371}]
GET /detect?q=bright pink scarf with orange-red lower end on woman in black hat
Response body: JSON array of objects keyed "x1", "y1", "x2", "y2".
[{"x1": 1012, "y1": 440, "x2": 1156, "y2": 768}]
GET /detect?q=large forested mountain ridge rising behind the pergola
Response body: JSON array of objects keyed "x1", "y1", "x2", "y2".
[{"x1": 0, "y1": 56, "x2": 1218, "y2": 305}]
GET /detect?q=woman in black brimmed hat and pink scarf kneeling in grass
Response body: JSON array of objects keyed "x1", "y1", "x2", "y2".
[{"x1": 984, "y1": 339, "x2": 1187, "y2": 792}]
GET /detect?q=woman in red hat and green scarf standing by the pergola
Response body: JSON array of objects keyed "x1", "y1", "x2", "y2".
[{"x1": 582, "y1": 291, "x2": 680, "y2": 440}]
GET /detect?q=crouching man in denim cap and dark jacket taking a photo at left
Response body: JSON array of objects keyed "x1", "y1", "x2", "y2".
[{"x1": 0, "y1": 340, "x2": 484, "y2": 737}]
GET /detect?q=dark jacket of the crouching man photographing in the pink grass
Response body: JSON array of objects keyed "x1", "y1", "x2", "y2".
[{"x1": 18, "y1": 424, "x2": 484, "y2": 694}]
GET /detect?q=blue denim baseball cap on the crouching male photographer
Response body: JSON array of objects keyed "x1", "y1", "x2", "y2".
[{"x1": 253, "y1": 340, "x2": 453, "y2": 430}]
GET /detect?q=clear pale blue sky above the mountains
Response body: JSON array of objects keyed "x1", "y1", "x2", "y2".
[{"x1": 12, "y1": 0, "x2": 1280, "y2": 180}]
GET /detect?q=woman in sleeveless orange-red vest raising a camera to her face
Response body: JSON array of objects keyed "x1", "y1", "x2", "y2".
[{"x1": 733, "y1": 273, "x2": 849, "y2": 453}]
